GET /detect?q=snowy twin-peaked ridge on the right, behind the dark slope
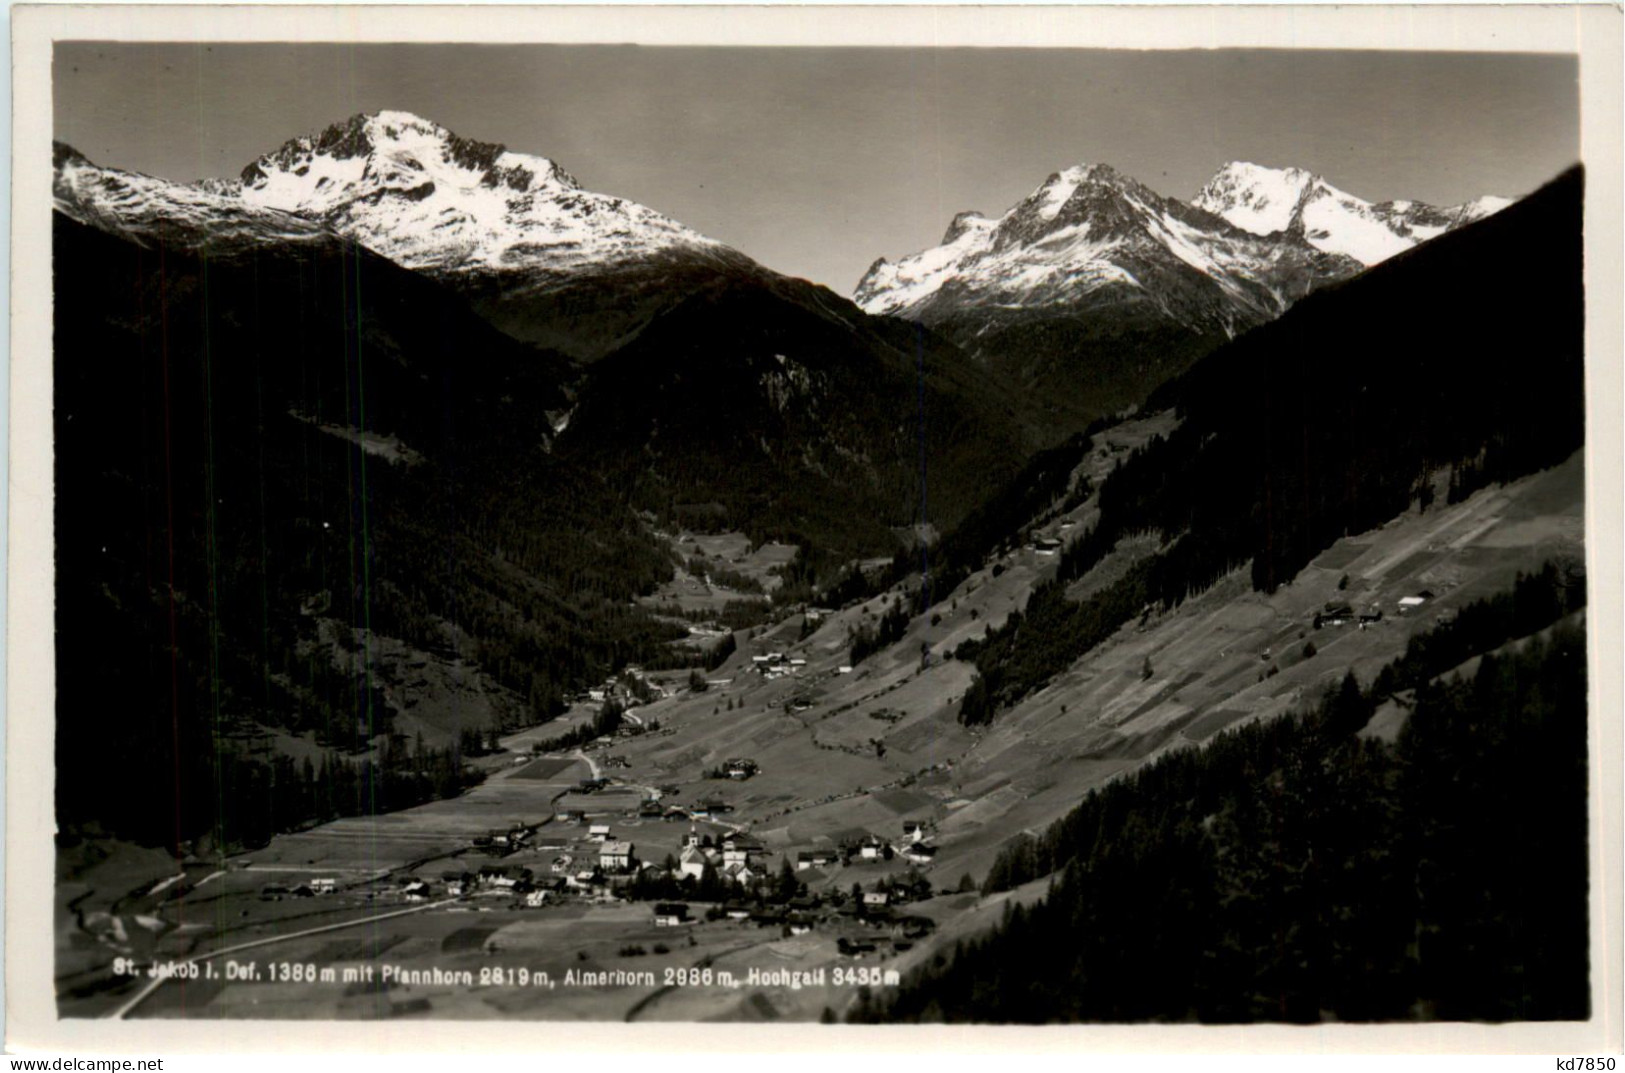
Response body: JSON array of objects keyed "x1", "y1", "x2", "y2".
[{"x1": 855, "y1": 163, "x2": 1510, "y2": 326}]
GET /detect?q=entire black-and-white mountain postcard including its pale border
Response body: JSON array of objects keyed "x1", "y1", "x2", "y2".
[{"x1": 8, "y1": 0, "x2": 1622, "y2": 1045}]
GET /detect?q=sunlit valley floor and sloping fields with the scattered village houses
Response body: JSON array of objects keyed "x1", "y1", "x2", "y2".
[{"x1": 62, "y1": 418, "x2": 1581, "y2": 1019}]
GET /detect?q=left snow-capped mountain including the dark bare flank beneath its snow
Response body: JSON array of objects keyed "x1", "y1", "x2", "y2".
[{"x1": 55, "y1": 111, "x2": 770, "y2": 361}]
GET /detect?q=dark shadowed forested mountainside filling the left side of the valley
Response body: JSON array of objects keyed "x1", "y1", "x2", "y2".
[{"x1": 54, "y1": 216, "x2": 685, "y2": 844}]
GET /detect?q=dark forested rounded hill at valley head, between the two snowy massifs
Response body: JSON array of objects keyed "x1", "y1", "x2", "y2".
[{"x1": 559, "y1": 276, "x2": 1022, "y2": 554}]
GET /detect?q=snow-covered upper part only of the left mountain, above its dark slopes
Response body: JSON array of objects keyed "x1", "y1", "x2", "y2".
[{"x1": 55, "y1": 111, "x2": 743, "y2": 275}]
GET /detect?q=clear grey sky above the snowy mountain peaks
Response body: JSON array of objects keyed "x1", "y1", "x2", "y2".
[{"x1": 54, "y1": 42, "x2": 1580, "y2": 293}]
